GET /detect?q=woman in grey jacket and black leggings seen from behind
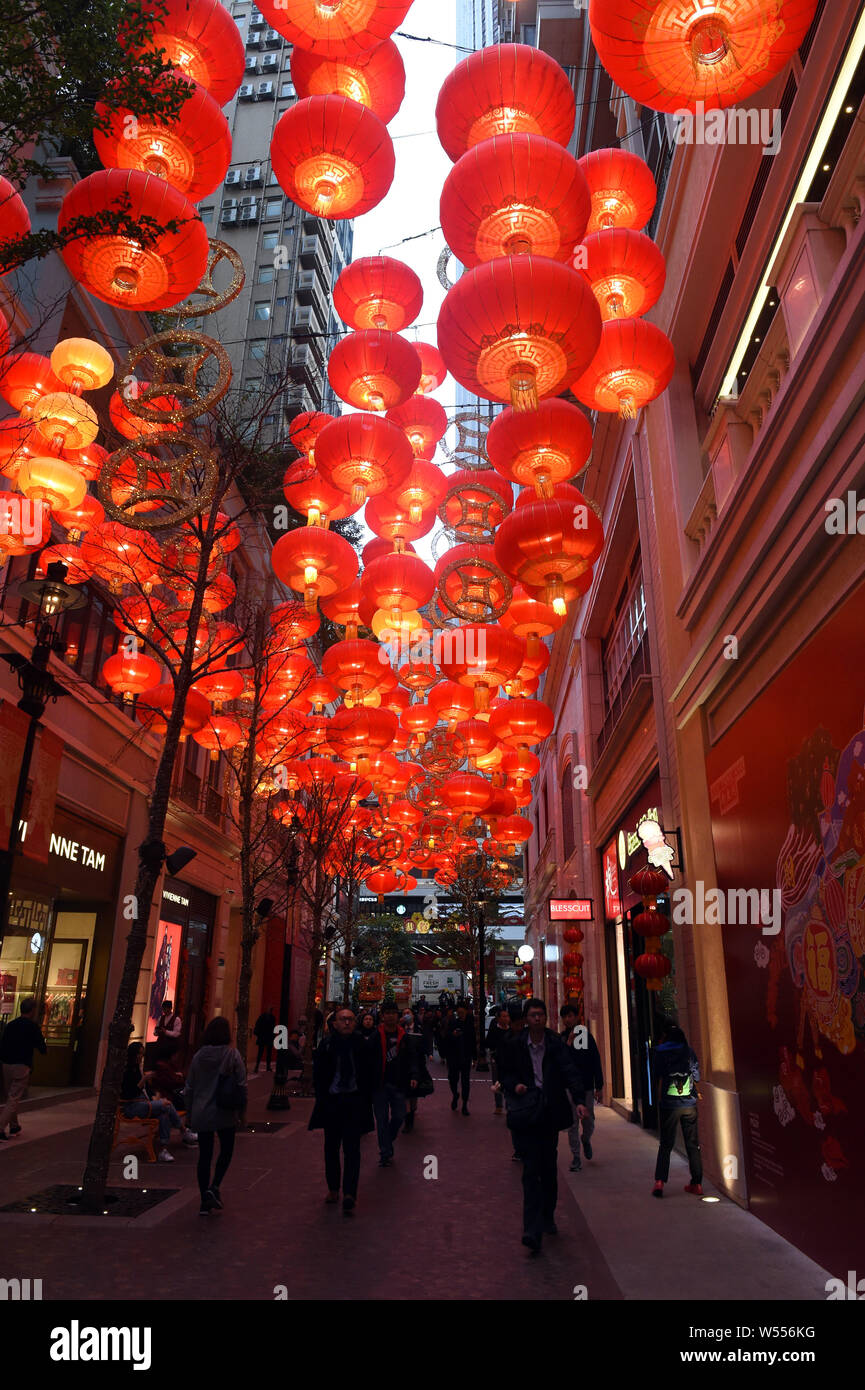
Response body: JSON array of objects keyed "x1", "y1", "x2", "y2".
[{"x1": 186, "y1": 1016, "x2": 246, "y2": 1216}]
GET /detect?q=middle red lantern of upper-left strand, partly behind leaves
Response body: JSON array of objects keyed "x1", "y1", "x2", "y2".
[{"x1": 93, "y1": 83, "x2": 231, "y2": 203}]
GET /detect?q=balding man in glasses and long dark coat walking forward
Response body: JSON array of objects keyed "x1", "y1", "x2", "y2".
[{"x1": 309, "y1": 1005, "x2": 375, "y2": 1216}]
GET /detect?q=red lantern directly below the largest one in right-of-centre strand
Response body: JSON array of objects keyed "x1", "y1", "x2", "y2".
[{"x1": 487, "y1": 399, "x2": 592, "y2": 496}]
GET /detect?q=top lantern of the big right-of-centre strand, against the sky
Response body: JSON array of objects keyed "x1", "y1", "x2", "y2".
[{"x1": 435, "y1": 43, "x2": 576, "y2": 160}]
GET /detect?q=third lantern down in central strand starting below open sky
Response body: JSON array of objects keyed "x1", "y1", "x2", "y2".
[{"x1": 316, "y1": 413, "x2": 413, "y2": 507}]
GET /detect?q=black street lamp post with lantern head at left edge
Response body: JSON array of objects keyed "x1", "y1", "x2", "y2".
[{"x1": 0, "y1": 560, "x2": 86, "y2": 942}]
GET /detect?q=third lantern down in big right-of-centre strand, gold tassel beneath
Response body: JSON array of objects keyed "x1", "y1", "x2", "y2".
[{"x1": 438, "y1": 255, "x2": 601, "y2": 410}]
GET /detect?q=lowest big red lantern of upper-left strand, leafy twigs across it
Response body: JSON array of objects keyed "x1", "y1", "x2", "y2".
[{"x1": 57, "y1": 170, "x2": 210, "y2": 311}]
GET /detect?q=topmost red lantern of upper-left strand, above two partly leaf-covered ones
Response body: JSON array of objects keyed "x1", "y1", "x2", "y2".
[{"x1": 127, "y1": 0, "x2": 246, "y2": 106}]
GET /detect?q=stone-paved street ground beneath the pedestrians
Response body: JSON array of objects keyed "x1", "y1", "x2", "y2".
[{"x1": 0, "y1": 1062, "x2": 829, "y2": 1301}]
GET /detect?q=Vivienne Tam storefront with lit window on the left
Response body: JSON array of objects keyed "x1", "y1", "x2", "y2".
[{"x1": 0, "y1": 808, "x2": 122, "y2": 1086}]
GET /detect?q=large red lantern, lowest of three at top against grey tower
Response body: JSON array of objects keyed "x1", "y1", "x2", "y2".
[{"x1": 270, "y1": 96, "x2": 395, "y2": 218}]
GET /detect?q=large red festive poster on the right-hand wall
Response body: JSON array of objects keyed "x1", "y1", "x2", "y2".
[{"x1": 706, "y1": 595, "x2": 865, "y2": 1269}]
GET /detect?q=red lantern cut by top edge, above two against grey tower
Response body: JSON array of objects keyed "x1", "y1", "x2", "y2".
[{"x1": 260, "y1": 0, "x2": 412, "y2": 57}]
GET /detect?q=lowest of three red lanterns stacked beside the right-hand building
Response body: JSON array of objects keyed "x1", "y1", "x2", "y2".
[{"x1": 572, "y1": 318, "x2": 676, "y2": 420}]
